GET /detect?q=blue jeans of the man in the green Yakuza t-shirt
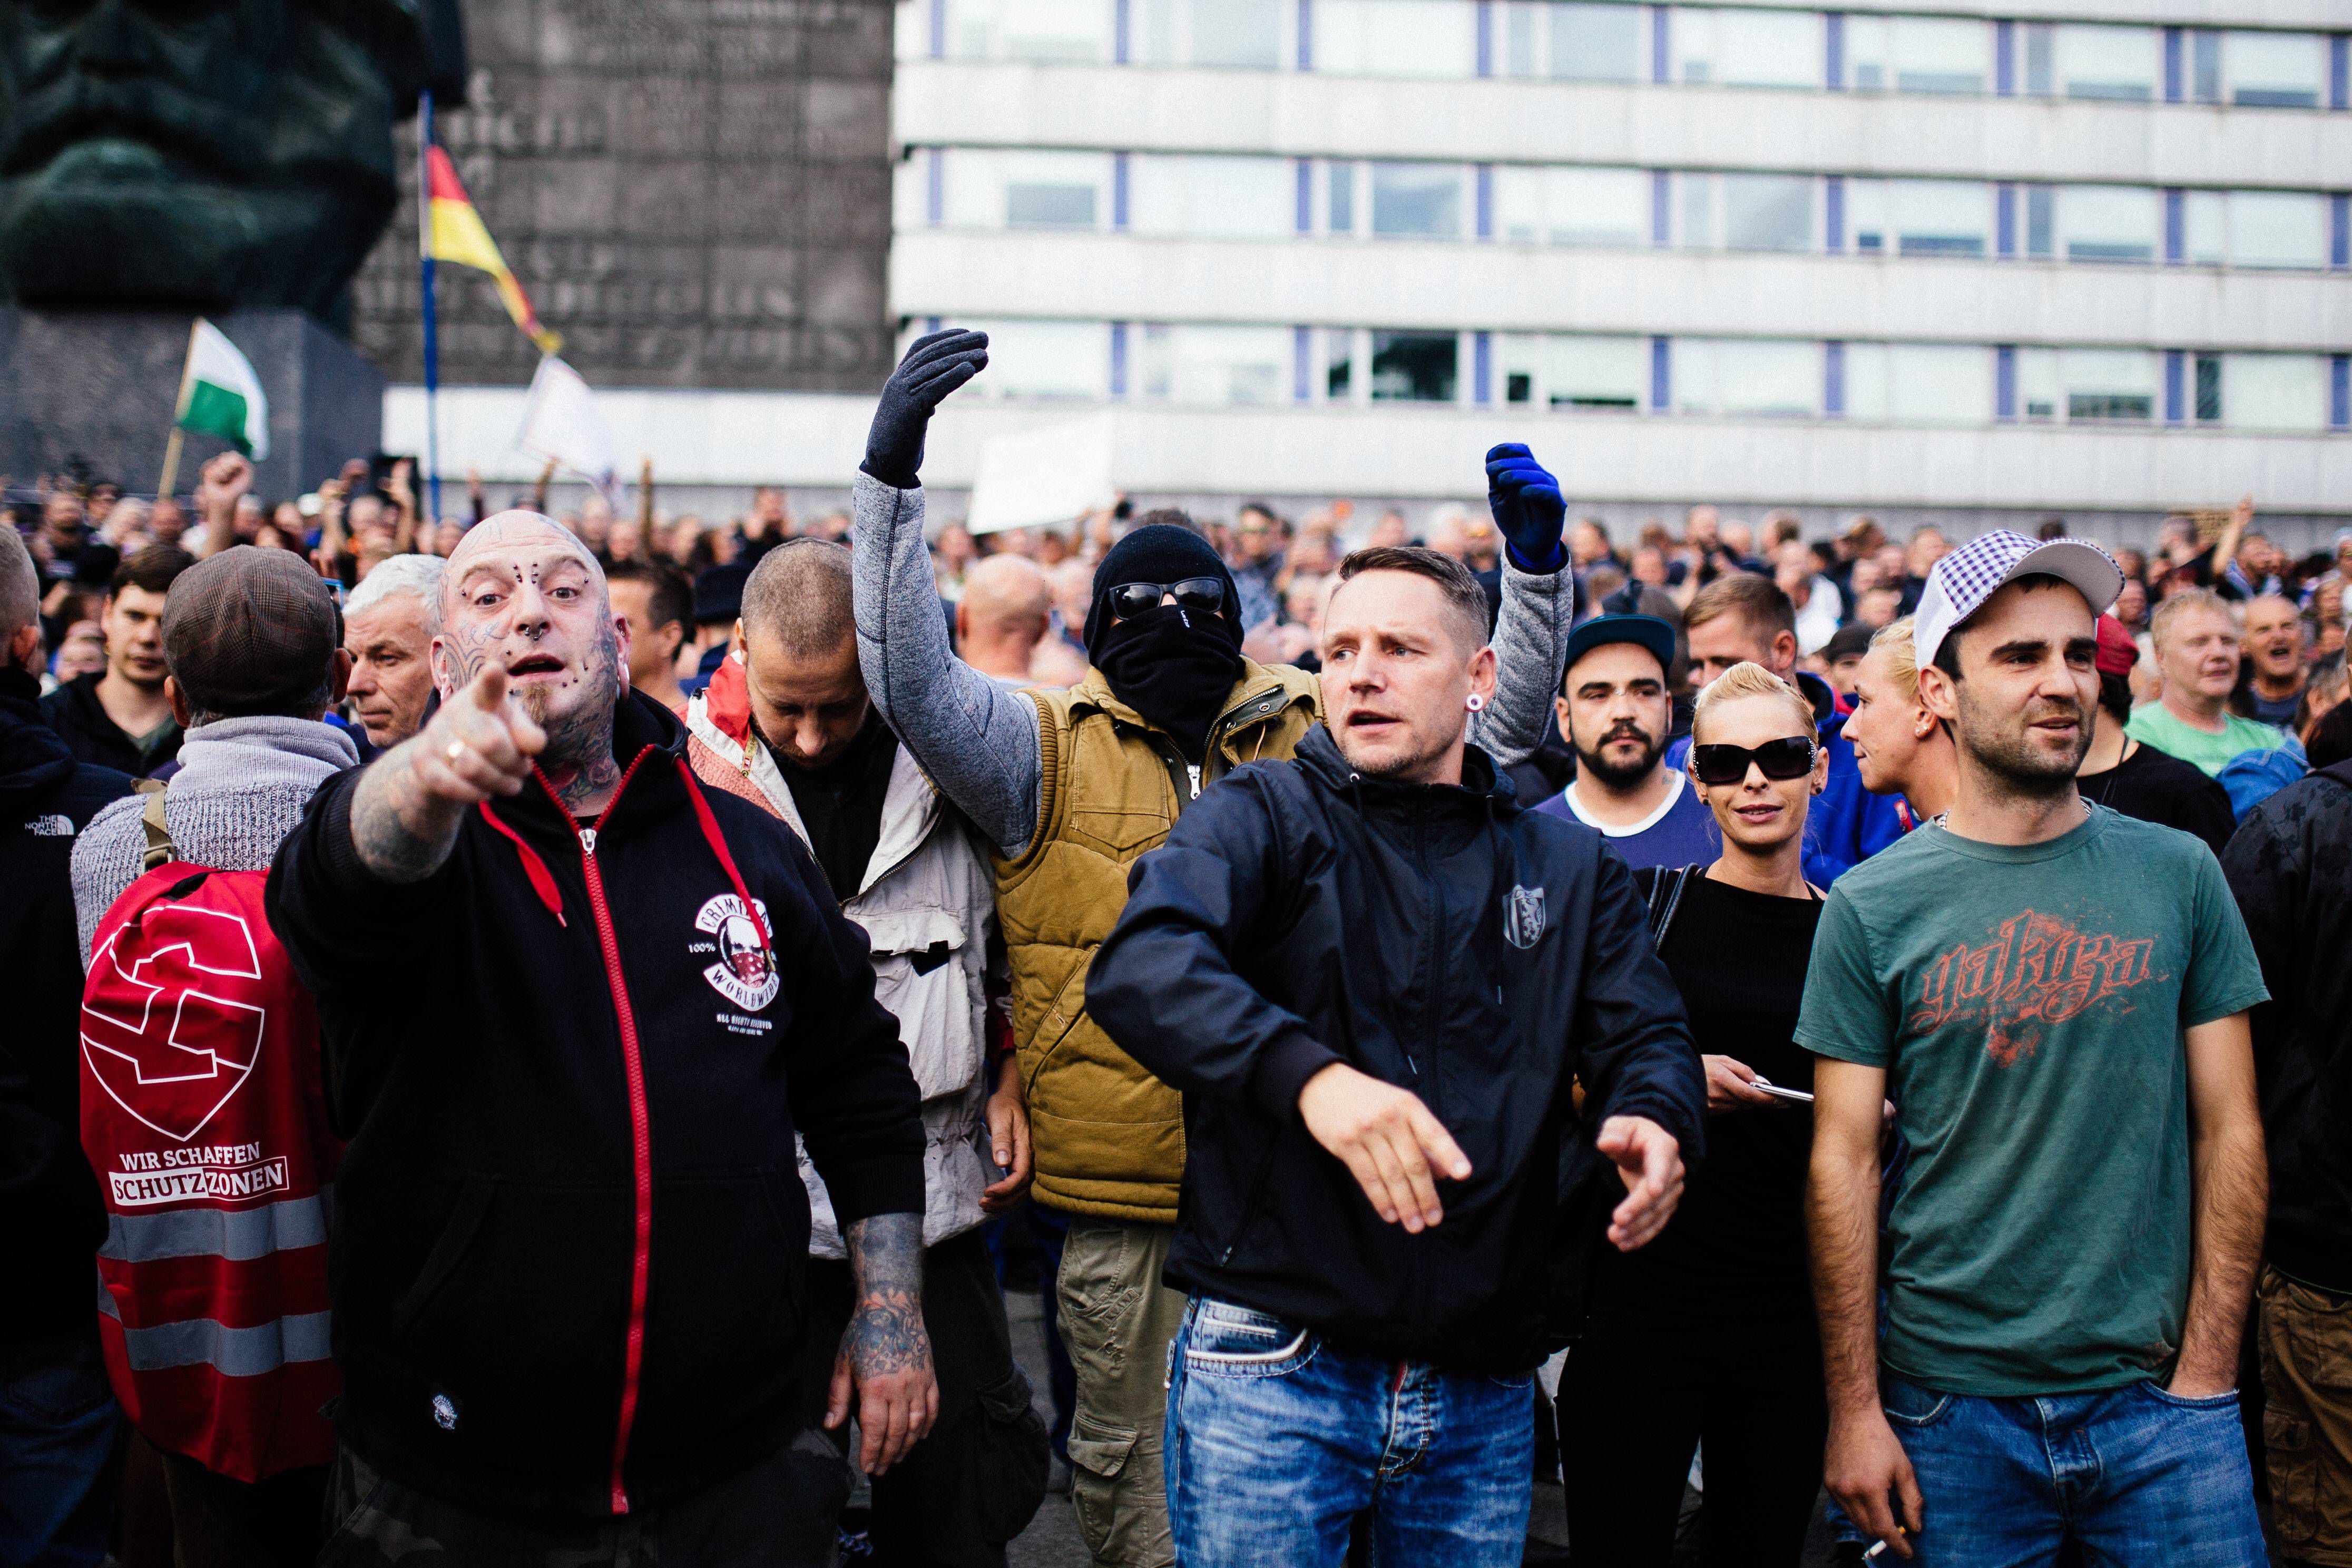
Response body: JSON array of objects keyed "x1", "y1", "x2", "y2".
[{"x1": 1879, "y1": 1373, "x2": 2270, "y2": 1568}]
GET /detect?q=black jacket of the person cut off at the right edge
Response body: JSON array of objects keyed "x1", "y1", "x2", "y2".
[{"x1": 2220, "y1": 762, "x2": 2352, "y2": 1295}]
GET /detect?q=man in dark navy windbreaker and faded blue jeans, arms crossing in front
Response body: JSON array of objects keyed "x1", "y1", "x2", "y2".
[{"x1": 1086, "y1": 548, "x2": 1705, "y2": 1568}]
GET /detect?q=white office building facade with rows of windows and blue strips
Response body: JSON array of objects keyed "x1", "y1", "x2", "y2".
[{"x1": 870, "y1": 0, "x2": 2352, "y2": 534}]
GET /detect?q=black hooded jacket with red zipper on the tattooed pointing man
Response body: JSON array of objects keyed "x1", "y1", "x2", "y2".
[{"x1": 268, "y1": 693, "x2": 922, "y2": 1516}]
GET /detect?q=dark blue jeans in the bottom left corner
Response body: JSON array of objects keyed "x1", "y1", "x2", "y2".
[{"x1": 0, "y1": 1321, "x2": 122, "y2": 1568}]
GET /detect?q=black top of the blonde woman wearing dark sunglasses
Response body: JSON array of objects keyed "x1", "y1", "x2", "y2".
[{"x1": 1592, "y1": 875, "x2": 1820, "y2": 1321}]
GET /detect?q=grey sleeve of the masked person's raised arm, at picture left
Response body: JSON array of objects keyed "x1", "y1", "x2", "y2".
[{"x1": 851, "y1": 473, "x2": 1044, "y2": 856}]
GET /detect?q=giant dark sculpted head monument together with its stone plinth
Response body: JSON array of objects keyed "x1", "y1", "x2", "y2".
[{"x1": 0, "y1": 0, "x2": 466, "y2": 496}]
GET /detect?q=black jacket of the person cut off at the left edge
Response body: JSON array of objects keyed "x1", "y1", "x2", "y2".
[{"x1": 0, "y1": 670, "x2": 132, "y2": 1345}]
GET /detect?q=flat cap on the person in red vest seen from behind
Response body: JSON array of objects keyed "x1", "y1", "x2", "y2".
[{"x1": 162, "y1": 545, "x2": 344, "y2": 717}]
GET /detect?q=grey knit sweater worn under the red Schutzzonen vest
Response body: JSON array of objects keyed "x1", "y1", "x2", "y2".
[{"x1": 73, "y1": 719, "x2": 360, "y2": 968}]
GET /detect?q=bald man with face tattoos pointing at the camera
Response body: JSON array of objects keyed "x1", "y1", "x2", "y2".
[{"x1": 268, "y1": 513, "x2": 936, "y2": 1568}]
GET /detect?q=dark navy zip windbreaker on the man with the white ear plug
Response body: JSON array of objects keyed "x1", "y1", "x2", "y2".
[{"x1": 1086, "y1": 727, "x2": 1705, "y2": 1373}]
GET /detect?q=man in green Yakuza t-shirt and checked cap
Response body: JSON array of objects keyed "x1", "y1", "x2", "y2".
[{"x1": 1797, "y1": 531, "x2": 2265, "y2": 1566}]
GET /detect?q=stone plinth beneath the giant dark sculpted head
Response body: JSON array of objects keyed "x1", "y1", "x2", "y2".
[{"x1": 0, "y1": 306, "x2": 384, "y2": 501}]
